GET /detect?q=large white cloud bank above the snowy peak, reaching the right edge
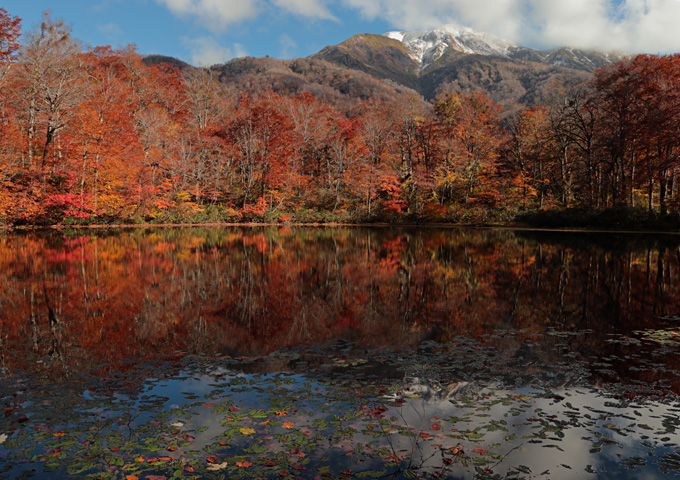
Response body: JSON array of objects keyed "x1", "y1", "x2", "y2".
[{"x1": 342, "y1": 0, "x2": 680, "y2": 53}]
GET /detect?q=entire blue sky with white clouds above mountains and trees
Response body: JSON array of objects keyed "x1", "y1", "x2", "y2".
[{"x1": 0, "y1": 0, "x2": 680, "y2": 66}]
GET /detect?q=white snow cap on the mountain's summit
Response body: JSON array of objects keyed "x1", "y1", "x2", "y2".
[{"x1": 384, "y1": 25, "x2": 518, "y2": 69}]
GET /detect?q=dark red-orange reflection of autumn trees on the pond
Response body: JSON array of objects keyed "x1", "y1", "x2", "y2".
[{"x1": 0, "y1": 228, "x2": 680, "y2": 392}]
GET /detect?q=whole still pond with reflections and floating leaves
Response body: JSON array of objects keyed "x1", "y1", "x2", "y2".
[{"x1": 0, "y1": 227, "x2": 680, "y2": 480}]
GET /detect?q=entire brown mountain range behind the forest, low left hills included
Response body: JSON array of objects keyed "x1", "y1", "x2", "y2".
[{"x1": 144, "y1": 25, "x2": 623, "y2": 115}]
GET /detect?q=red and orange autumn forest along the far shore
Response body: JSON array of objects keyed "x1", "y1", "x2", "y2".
[{"x1": 0, "y1": 8, "x2": 680, "y2": 225}]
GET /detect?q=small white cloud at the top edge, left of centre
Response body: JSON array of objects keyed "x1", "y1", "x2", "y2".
[{"x1": 156, "y1": 0, "x2": 263, "y2": 33}]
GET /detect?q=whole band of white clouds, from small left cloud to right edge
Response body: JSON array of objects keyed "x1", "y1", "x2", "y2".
[{"x1": 156, "y1": 0, "x2": 680, "y2": 53}]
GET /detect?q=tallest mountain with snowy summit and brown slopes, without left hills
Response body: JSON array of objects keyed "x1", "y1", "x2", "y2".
[{"x1": 312, "y1": 25, "x2": 623, "y2": 110}]
